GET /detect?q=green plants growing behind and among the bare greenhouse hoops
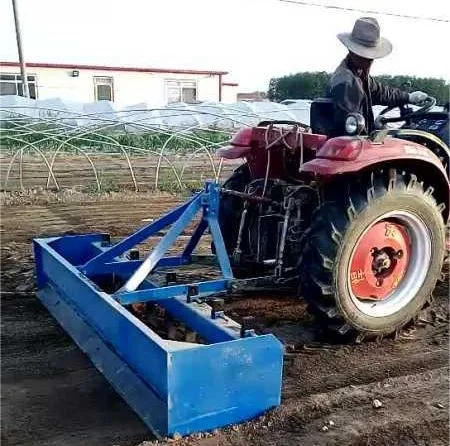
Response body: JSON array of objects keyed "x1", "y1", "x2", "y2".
[{"x1": 0, "y1": 122, "x2": 230, "y2": 194}]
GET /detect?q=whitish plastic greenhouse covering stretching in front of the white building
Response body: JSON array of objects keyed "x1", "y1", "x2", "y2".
[{"x1": 0, "y1": 96, "x2": 438, "y2": 132}]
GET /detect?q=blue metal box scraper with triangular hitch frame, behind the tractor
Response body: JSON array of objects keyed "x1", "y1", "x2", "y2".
[{"x1": 33, "y1": 183, "x2": 283, "y2": 436}]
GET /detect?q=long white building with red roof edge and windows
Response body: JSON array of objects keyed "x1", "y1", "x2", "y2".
[{"x1": 0, "y1": 62, "x2": 238, "y2": 107}]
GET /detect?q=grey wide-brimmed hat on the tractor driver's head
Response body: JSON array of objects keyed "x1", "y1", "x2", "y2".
[{"x1": 337, "y1": 17, "x2": 392, "y2": 59}]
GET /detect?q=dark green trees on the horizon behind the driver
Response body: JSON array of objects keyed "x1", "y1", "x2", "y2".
[{"x1": 267, "y1": 71, "x2": 450, "y2": 105}]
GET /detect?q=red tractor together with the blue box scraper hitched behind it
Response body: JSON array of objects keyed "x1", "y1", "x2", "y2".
[{"x1": 33, "y1": 96, "x2": 450, "y2": 437}]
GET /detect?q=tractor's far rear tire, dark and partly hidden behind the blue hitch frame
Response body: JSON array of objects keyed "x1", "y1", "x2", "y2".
[{"x1": 216, "y1": 163, "x2": 251, "y2": 255}]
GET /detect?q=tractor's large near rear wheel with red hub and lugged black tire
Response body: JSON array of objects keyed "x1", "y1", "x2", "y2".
[{"x1": 298, "y1": 169, "x2": 445, "y2": 341}]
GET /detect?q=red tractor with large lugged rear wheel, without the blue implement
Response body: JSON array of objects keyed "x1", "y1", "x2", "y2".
[{"x1": 218, "y1": 98, "x2": 450, "y2": 340}]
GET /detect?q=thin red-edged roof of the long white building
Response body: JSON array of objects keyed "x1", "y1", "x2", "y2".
[{"x1": 0, "y1": 62, "x2": 228, "y2": 75}]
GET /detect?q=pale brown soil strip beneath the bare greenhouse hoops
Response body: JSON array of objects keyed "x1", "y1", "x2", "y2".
[{"x1": 0, "y1": 153, "x2": 241, "y2": 191}]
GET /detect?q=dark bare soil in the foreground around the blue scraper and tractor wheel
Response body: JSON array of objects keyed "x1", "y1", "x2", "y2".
[{"x1": 1, "y1": 193, "x2": 449, "y2": 446}]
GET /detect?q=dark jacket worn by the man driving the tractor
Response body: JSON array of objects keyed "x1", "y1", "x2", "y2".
[{"x1": 328, "y1": 57, "x2": 409, "y2": 136}]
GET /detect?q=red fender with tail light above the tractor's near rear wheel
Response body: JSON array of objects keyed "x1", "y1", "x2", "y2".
[{"x1": 300, "y1": 136, "x2": 450, "y2": 218}]
